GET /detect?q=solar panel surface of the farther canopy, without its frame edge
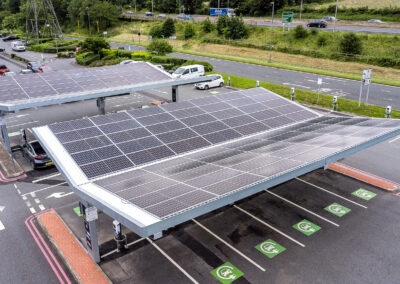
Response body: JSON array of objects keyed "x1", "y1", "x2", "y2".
[{"x1": 0, "y1": 62, "x2": 171, "y2": 102}]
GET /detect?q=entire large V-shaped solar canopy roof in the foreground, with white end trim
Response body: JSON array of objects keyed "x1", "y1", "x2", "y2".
[{"x1": 34, "y1": 88, "x2": 400, "y2": 237}]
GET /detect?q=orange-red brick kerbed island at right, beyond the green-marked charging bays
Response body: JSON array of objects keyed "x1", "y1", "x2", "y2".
[{"x1": 328, "y1": 162, "x2": 400, "y2": 192}]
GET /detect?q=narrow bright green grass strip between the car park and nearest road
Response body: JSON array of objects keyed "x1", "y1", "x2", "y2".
[{"x1": 213, "y1": 72, "x2": 400, "y2": 119}]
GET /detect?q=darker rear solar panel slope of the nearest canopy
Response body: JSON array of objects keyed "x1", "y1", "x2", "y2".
[{"x1": 49, "y1": 88, "x2": 318, "y2": 179}]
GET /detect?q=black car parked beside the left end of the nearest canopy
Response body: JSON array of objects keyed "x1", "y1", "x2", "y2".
[{"x1": 21, "y1": 140, "x2": 53, "y2": 170}]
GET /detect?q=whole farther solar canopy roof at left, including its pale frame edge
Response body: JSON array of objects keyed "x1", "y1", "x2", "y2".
[{"x1": 0, "y1": 62, "x2": 216, "y2": 111}]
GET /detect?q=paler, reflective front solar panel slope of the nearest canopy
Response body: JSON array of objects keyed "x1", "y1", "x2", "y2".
[{"x1": 95, "y1": 117, "x2": 400, "y2": 219}]
